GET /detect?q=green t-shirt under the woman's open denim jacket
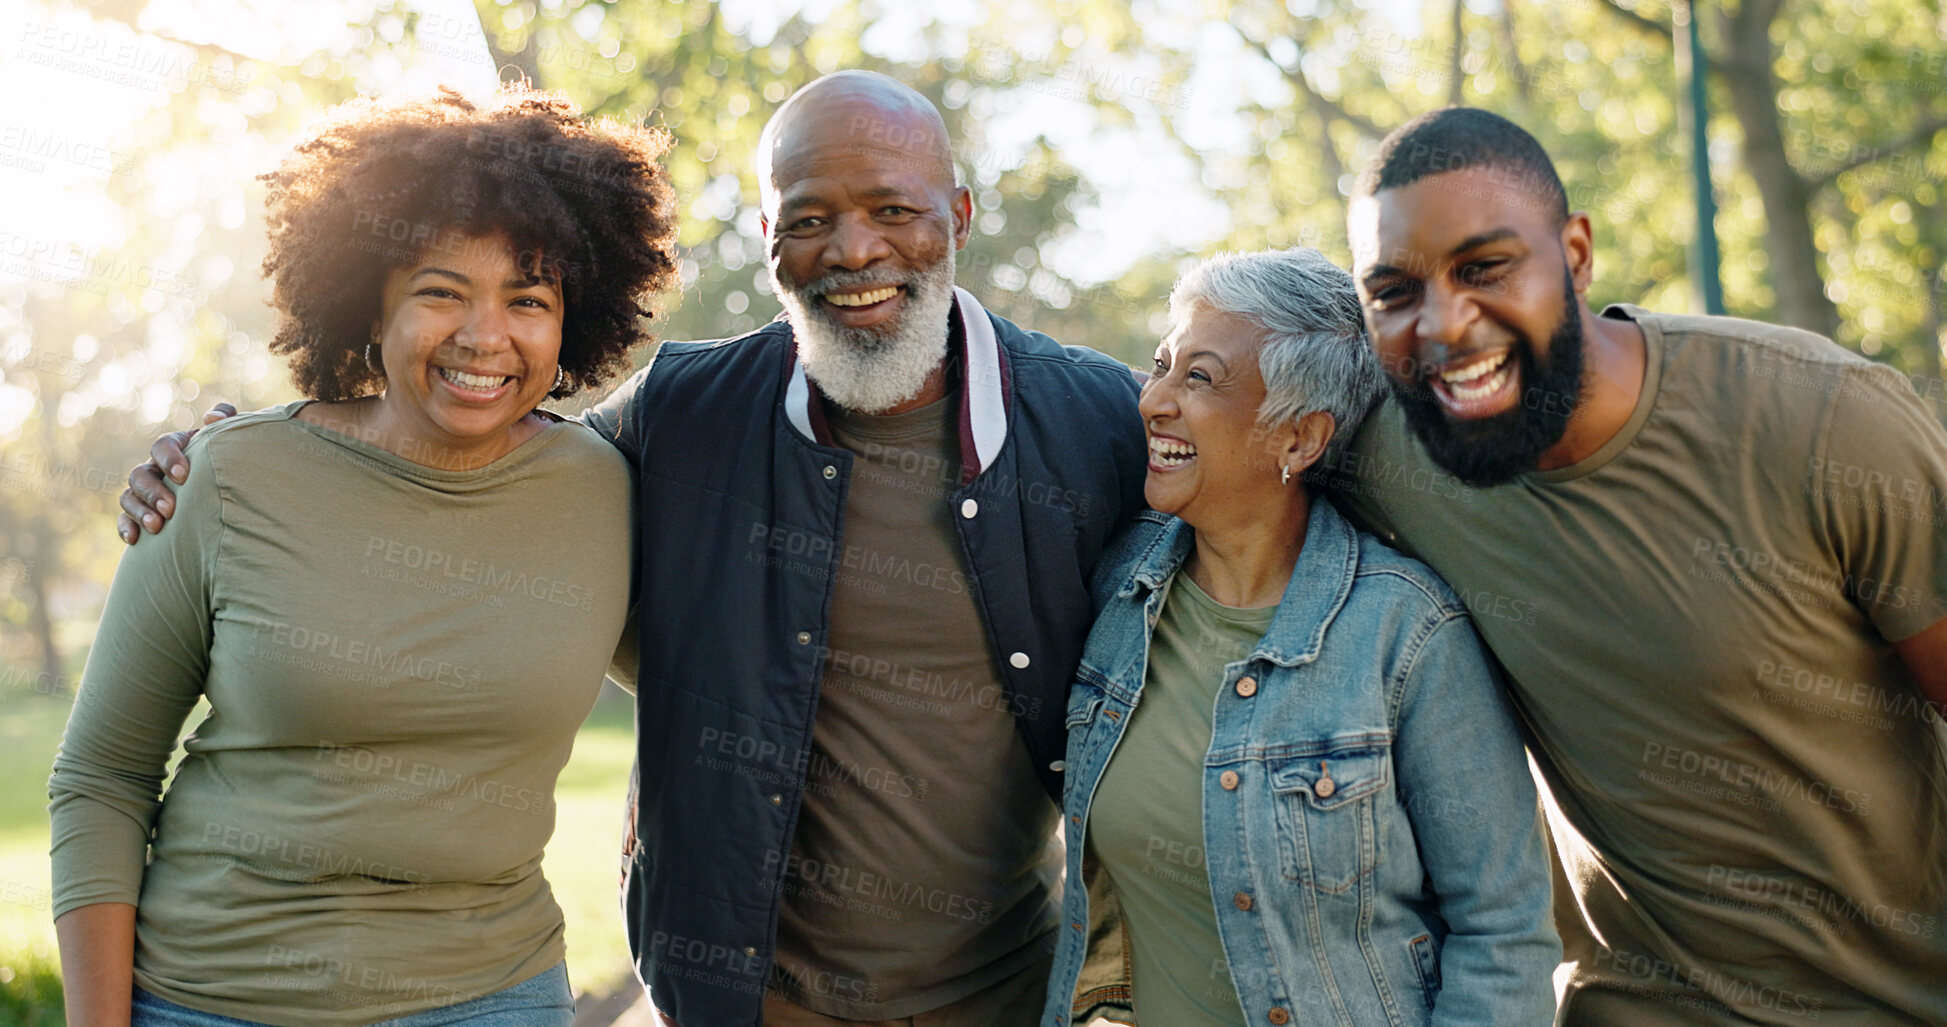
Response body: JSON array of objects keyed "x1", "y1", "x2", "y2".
[{"x1": 1088, "y1": 573, "x2": 1277, "y2": 1027}]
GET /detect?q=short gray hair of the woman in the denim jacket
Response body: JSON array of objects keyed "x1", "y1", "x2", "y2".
[{"x1": 1170, "y1": 247, "x2": 1386, "y2": 468}]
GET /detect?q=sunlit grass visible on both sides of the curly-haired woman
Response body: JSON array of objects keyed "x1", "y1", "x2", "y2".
[{"x1": 0, "y1": 678, "x2": 635, "y2": 1027}]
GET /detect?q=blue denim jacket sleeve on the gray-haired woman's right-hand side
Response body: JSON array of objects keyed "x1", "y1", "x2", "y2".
[{"x1": 1394, "y1": 614, "x2": 1561, "y2": 1027}]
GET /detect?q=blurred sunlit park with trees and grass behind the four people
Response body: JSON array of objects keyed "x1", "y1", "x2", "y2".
[{"x1": 0, "y1": 0, "x2": 1947, "y2": 1025}]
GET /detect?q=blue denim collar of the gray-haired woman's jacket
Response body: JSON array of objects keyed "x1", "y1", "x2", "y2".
[{"x1": 1118, "y1": 495, "x2": 1359, "y2": 666}]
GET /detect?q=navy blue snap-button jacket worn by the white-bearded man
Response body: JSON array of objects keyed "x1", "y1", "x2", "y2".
[{"x1": 586, "y1": 290, "x2": 1147, "y2": 1027}]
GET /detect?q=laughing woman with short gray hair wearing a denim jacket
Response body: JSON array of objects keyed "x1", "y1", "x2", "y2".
[{"x1": 1042, "y1": 249, "x2": 1561, "y2": 1027}]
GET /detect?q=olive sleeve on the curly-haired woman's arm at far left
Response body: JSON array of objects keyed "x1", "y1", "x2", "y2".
[{"x1": 47, "y1": 433, "x2": 222, "y2": 918}]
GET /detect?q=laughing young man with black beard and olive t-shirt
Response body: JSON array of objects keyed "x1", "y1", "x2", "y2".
[{"x1": 1338, "y1": 107, "x2": 1947, "y2": 1027}]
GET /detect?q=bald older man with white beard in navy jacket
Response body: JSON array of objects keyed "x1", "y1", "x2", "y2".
[{"x1": 123, "y1": 72, "x2": 1147, "y2": 1027}]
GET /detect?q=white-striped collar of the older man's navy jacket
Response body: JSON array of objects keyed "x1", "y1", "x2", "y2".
[{"x1": 785, "y1": 286, "x2": 1010, "y2": 485}]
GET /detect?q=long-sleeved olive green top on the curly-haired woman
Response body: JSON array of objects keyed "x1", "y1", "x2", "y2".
[{"x1": 49, "y1": 403, "x2": 631, "y2": 1027}]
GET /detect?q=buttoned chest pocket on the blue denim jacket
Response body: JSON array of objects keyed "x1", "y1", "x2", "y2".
[{"x1": 1269, "y1": 746, "x2": 1392, "y2": 894}]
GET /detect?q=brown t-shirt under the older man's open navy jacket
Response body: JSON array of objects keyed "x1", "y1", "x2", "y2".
[{"x1": 771, "y1": 398, "x2": 1061, "y2": 1019}]
